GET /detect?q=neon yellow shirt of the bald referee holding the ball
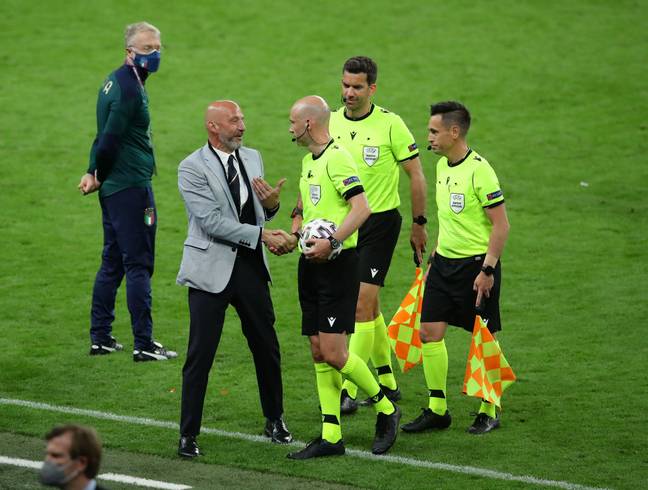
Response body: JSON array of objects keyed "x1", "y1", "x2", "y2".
[{"x1": 299, "y1": 140, "x2": 364, "y2": 249}]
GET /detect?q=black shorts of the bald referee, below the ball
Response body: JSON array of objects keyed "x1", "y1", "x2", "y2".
[{"x1": 297, "y1": 248, "x2": 360, "y2": 336}]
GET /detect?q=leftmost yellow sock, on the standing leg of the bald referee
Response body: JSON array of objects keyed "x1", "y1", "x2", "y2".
[{"x1": 315, "y1": 362, "x2": 342, "y2": 444}]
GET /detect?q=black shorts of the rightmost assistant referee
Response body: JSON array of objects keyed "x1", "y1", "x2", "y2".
[{"x1": 421, "y1": 253, "x2": 502, "y2": 333}]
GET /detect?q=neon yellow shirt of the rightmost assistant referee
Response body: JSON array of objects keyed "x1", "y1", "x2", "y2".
[{"x1": 436, "y1": 150, "x2": 504, "y2": 259}]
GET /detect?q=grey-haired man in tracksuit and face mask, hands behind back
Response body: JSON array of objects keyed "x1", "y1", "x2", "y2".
[{"x1": 79, "y1": 22, "x2": 177, "y2": 361}]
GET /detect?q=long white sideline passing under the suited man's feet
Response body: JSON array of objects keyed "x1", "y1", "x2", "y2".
[{"x1": 0, "y1": 398, "x2": 604, "y2": 490}]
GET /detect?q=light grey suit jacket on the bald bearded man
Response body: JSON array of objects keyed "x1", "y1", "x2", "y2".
[{"x1": 176, "y1": 144, "x2": 272, "y2": 293}]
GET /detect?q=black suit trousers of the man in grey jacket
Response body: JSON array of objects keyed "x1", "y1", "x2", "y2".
[{"x1": 180, "y1": 254, "x2": 283, "y2": 436}]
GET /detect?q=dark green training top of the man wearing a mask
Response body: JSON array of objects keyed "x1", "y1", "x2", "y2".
[{"x1": 88, "y1": 65, "x2": 155, "y2": 197}]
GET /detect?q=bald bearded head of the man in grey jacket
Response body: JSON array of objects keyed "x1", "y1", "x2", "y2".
[{"x1": 205, "y1": 100, "x2": 245, "y2": 153}]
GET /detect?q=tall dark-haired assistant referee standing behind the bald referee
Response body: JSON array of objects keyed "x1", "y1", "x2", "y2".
[{"x1": 330, "y1": 56, "x2": 427, "y2": 413}]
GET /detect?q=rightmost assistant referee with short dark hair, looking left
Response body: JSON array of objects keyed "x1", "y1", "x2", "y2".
[{"x1": 402, "y1": 101, "x2": 509, "y2": 434}]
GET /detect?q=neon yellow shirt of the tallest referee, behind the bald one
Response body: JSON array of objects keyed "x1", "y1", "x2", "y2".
[{"x1": 329, "y1": 104, "x2": 418, "y2": 213}]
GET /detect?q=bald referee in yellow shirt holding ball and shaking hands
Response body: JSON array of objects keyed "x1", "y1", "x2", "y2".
[{"x1": 288, "y1": 96, "x2": 401, "y2": 460}]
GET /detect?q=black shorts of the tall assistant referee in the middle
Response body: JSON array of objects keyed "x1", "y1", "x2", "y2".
[{"x1": 358, "y1": 209, "x2": 403, "y2": 286}]
